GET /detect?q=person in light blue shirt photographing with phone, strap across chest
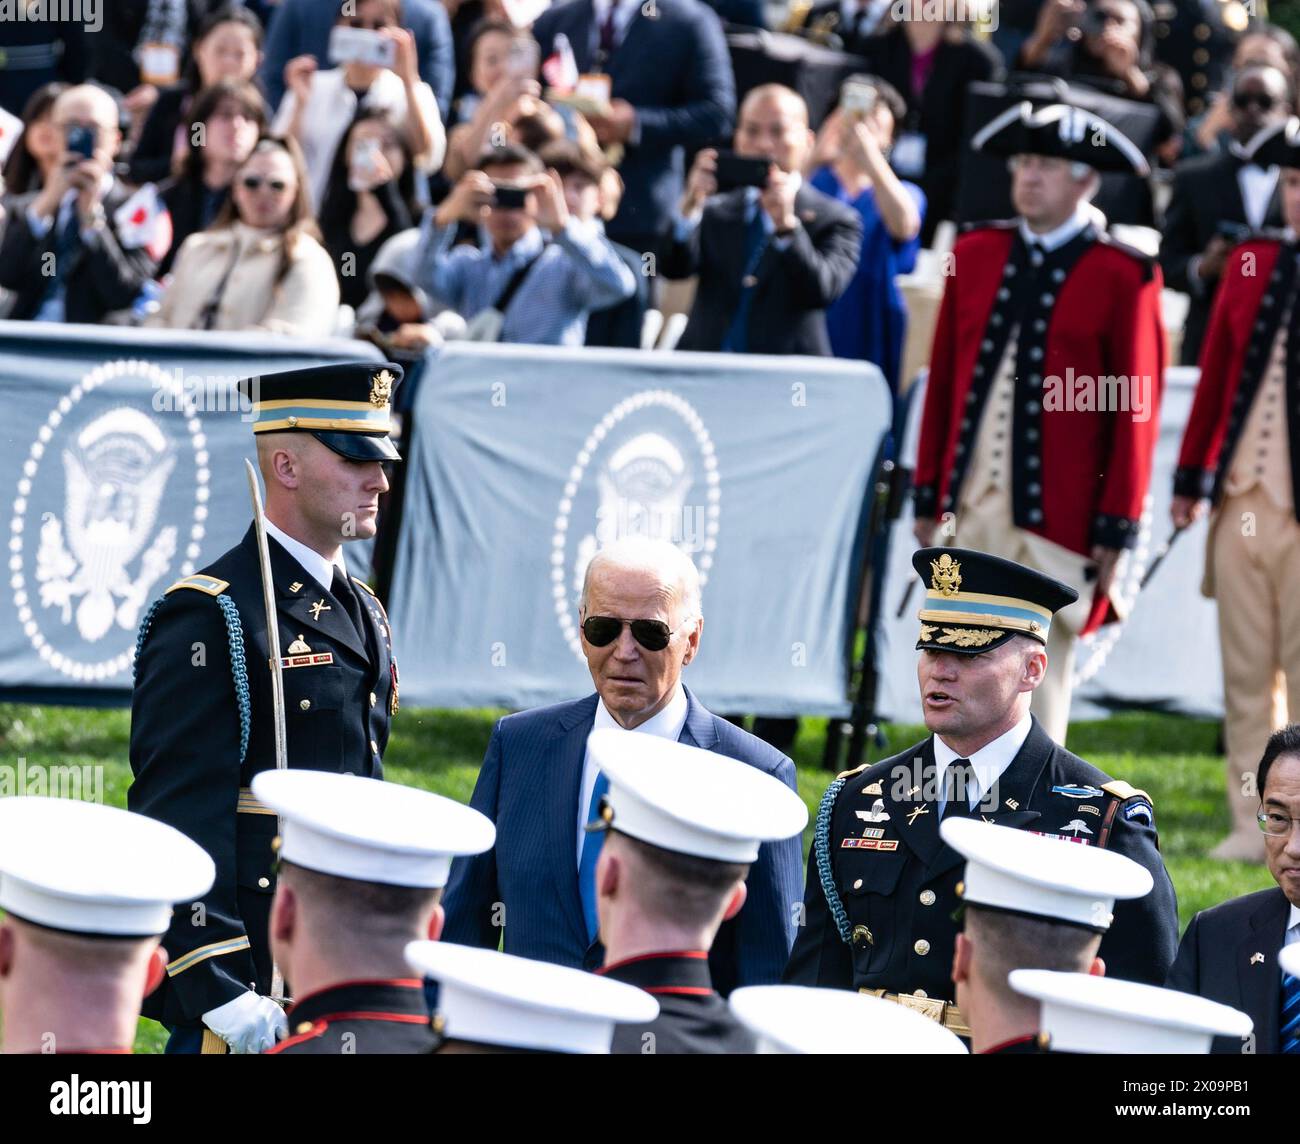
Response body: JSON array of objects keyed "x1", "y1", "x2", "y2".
[{"x1": 416, "y1": 144, "x2": 637, "y2": 346}]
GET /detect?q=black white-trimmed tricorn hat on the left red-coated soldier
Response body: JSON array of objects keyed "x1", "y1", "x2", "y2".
[{"x1": 971, "y1": 100, "x2": 1151, "y2": 178}]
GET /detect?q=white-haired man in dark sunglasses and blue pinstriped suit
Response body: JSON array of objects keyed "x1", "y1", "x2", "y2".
[{"x1": 443, "y1": 540, "x2": 802, "y2": 996}]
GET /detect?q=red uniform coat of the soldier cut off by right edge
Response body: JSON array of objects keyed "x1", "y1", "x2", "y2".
[{"x1": 1174, "y1": 238, "x2": 1300, "y2": 519}]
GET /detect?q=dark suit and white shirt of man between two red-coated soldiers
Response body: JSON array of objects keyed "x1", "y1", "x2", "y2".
[{"x1": 1160, "y1": 153, "x2": 1283, "y2": 365}]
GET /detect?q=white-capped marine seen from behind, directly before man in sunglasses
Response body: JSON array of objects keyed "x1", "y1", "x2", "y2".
[{"x1": 588, "y1": 728, "x2": 809, "y2": 1054}]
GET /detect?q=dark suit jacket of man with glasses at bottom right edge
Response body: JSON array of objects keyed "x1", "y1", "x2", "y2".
[{"x1": 1165, "y1": 887, "x2": 1291, "y2": 1053}]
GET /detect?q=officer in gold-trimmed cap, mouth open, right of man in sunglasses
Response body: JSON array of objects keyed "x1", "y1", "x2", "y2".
[{"x1": 785, "y1": 549, "x2": 1178, "y2": 1036}]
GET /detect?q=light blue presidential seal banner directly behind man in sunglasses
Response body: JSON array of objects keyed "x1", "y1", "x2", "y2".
[{"x1": 389, "y1": 342, "x2": 891, "y2": 715}]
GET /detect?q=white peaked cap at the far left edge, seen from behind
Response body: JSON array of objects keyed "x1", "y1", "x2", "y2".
[{"x1": 0, "y1": 797, "x2": 216, "y2": 937}]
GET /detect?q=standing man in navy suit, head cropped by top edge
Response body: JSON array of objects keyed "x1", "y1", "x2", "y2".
[{"x1": 533, "y1": 0, "x2": 736, "y2": 266}]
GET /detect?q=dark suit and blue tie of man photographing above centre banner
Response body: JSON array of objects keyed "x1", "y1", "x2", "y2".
[{"x1": 664, "y1": 186, "x2": 862, "y2": 358}]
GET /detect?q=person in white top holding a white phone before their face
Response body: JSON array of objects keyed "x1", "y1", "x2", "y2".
[{"x1": 272, "y1": 0, "x2": 447, "y2": 209}]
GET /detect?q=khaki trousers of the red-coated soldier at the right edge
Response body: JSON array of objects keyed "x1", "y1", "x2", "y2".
[{"x1": 1209, "y1": 485, "x2": 1300, "y2": 850}]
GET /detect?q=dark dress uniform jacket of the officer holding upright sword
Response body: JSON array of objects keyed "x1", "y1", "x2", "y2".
[{"x1": 127, "y1": 528, "x2": 397, "y2": 1024}]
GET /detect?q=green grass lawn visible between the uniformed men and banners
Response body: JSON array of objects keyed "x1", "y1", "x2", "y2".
[{"x1": 0, "y1": 705, "x2": 1273, "y2": 1053}]
